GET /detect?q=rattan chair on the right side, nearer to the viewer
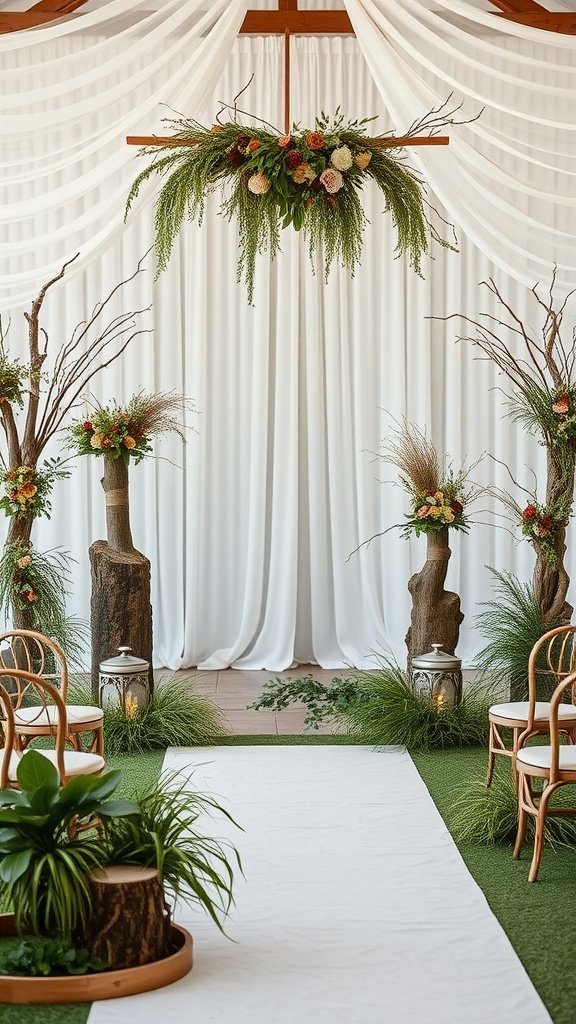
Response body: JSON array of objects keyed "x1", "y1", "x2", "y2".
[{"x1": 513, "y1": 672, "x2": 576, "y2": 882}]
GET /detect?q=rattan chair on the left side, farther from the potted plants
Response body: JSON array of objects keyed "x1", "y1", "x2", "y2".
[{"x1": 0, "y1": 630, "x2": 104, "y2": 757}]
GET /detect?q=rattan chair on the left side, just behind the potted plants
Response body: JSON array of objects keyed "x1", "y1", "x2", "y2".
[{"x1": 0, "y1": 669, "x2": 106, "y2": 788}]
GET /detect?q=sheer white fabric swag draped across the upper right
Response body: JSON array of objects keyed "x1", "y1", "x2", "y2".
[{"x1": 345, "y1": 0, "x2": 576, "y2": 292}]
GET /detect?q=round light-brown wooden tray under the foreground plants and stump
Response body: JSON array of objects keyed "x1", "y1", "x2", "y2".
[{"x1": 0, "y1": 913, "x2": 193, "y2": 1002}]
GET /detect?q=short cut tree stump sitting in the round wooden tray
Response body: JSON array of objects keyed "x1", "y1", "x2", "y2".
[{"x1": 83, "y1": 865, "x2": 171, "y2": 970}]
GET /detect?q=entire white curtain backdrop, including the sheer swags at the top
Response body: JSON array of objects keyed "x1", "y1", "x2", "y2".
[{"x1": 0, "y1": 0, "x2": 576, "y2": 671}]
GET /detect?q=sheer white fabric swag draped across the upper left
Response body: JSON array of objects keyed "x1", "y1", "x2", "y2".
[{"x1": 0, "y1": 0, "x2": 247, "y2": 310}]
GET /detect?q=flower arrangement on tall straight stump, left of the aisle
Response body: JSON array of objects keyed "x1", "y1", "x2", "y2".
[{"x1": 68, "y1": 391, "x2": 191, "y2": 698}]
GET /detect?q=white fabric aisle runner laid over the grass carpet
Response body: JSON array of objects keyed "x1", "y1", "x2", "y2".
[{"x1": 88, "y1": 745, "x2": 550, "y2": 1024}]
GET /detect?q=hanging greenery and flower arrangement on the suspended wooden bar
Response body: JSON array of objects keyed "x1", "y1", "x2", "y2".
[{"x1": 126, "y1": 104, "x2": 455, "y2": 302}]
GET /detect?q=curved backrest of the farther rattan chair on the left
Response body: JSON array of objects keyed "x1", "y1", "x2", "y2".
[{"x1": 0, "y1": 630, "x2": 68, "y2": 708}]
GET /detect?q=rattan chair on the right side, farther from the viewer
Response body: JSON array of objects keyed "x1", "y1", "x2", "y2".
[{"x1": 486, "y1": 626, "x2": 576, "y2": 786}]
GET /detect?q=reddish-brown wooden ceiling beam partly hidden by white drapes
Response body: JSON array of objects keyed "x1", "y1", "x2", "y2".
[{"x1": 0, "y1": 0, "x2": 576, "y2": 36}]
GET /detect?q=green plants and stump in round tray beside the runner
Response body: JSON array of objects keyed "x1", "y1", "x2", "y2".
[{"x1": 0, "y1": 750, "x2": 241, "y2": 1002}]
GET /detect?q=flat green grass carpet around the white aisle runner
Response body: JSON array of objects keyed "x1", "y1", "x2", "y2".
[{"x1": 0, "y1": 734, "x2": 576, "y2": 1024}]
